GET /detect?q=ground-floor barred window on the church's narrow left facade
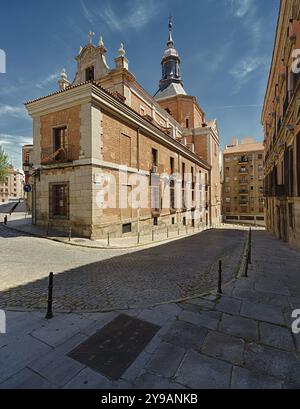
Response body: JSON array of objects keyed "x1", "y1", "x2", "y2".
[{"x1": 50, "y1": 183, "x2": 69, "y2": 219}]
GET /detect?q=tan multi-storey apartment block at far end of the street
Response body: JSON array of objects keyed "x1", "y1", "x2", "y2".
[{"x1": 223, "y1": 140, "x2": 265, "y2": 225}]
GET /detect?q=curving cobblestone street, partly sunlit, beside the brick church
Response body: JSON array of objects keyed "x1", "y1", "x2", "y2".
[{"x1": 0, "y1": 227, "x2": 246, "y2": 312}]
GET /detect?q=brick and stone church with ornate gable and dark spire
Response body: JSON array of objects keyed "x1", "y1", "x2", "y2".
[{"x1": 26, "y1": 22, "x2": 221, "y2": 239}]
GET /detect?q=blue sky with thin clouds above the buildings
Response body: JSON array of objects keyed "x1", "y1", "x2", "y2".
[{"x1": 0, "y1": 0, "x2": 279, "y2": 167}]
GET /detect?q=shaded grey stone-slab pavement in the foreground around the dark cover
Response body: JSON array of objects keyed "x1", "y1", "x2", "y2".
[{"x1": 0, "y1": 231, "x2": 300, "y2": 389}]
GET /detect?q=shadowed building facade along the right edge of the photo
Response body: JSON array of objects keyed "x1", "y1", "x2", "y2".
[{"x1": 262, "y1": 0, "x2": 300, "y2": 247}]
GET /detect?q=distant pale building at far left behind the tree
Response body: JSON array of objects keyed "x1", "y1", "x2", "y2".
[{"x1": 0, "y1": 166, "x2": 24, "y2": 203}]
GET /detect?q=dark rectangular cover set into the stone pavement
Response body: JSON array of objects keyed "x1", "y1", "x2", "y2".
[{"x1": 68, "y1": 315, "x2": 160, "y2": 380}]
